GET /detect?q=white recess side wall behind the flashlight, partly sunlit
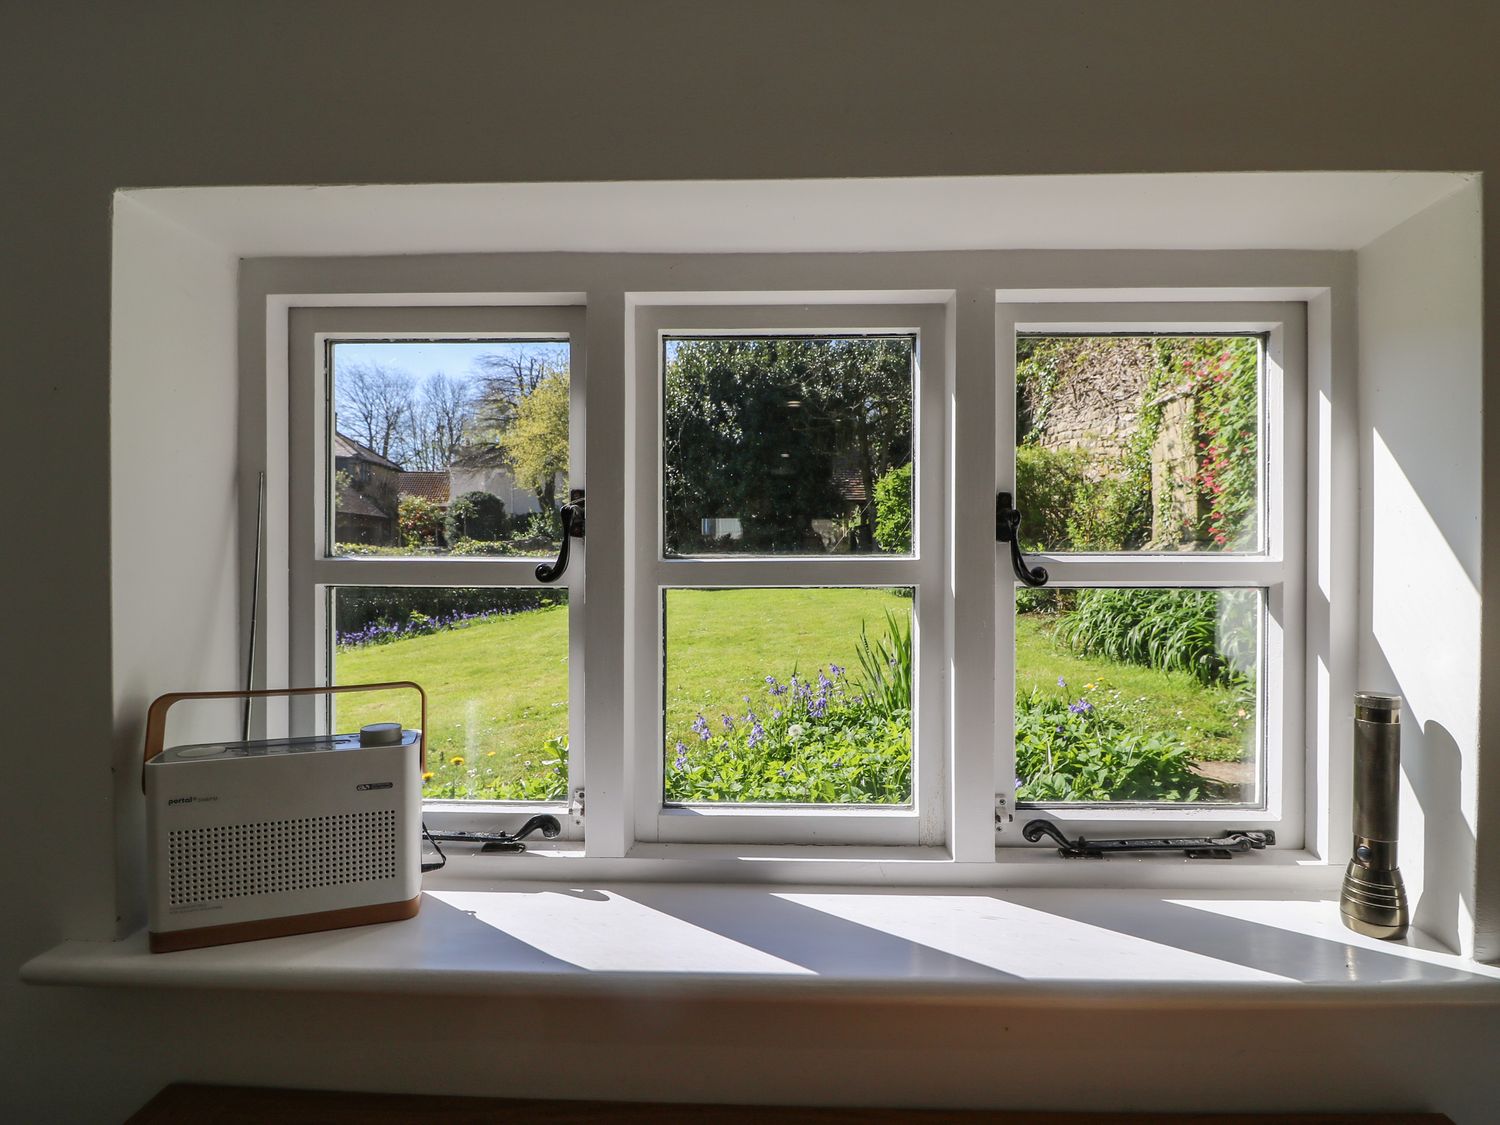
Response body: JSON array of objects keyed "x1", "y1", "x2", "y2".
[{"x1": 1358, "y1": 186, "x2": 1496, "y2": 953}]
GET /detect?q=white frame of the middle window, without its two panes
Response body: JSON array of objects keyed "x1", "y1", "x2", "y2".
[{"x1": 627, "y1": 304, "x2": 948, "y2": 846}]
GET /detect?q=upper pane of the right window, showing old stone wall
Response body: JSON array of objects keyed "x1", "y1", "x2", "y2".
[{"x1": 1016, "y1": 336, "x2": 1263, "y2": 552}]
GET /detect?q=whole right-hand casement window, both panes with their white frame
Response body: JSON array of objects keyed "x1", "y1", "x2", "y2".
[{"x1": 999, "y1": 305, "x2": 1305, "y2": 833}]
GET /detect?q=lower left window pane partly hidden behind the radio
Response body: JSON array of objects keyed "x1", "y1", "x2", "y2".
[{"x1": 329, "y1": 587, "x2": 569, "y2": 801}]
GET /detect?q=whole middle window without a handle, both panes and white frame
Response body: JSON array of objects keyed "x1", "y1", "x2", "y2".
[{"x1": 632, "y1": 305, "x2": 945, "y2": 845}]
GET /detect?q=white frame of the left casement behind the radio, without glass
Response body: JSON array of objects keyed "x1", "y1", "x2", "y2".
[{"x1": 288, "y1": 306, "x2": 588, "y2": 839}]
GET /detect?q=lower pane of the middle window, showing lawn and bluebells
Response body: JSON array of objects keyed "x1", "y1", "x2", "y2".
[{"x1": 663, "y1": 588, "x2": 912, "y2": 806}]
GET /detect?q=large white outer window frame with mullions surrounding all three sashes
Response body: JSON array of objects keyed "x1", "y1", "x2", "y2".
[{"x1": 258, "y1": 258, "x2": 1338, "y2": 887}]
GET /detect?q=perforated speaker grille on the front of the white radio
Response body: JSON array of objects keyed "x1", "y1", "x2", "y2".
[{"x1": 167, "y1": 809, "x2": 396, "y2": 906}]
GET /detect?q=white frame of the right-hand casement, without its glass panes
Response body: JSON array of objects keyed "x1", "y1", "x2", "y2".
[{"x1": 995, "y1": 302, "x2": 1307, "y2": 848}]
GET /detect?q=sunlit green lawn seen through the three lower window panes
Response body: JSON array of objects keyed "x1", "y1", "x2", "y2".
[{"x1": 336, "y1": 590, "x2": 1254, "y2": 795}]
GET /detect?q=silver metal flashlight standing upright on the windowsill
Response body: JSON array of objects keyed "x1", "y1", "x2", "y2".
[{"x1": 1338, "y1": 692, "x2": 1412, "y2": 941}]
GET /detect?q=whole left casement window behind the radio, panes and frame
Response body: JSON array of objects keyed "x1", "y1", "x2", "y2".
[{"x1": 291, "y1": 309, "x2": 584, "y2": 840}]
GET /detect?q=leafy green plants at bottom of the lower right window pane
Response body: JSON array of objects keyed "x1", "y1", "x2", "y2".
[{"x1": 1016, "y1": 690, "x2": 1202, "y2": 803}]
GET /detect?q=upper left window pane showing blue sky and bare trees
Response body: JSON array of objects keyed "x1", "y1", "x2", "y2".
[{"x1": 329, "y1": 341, "x2": 569, "y2": 557}]
